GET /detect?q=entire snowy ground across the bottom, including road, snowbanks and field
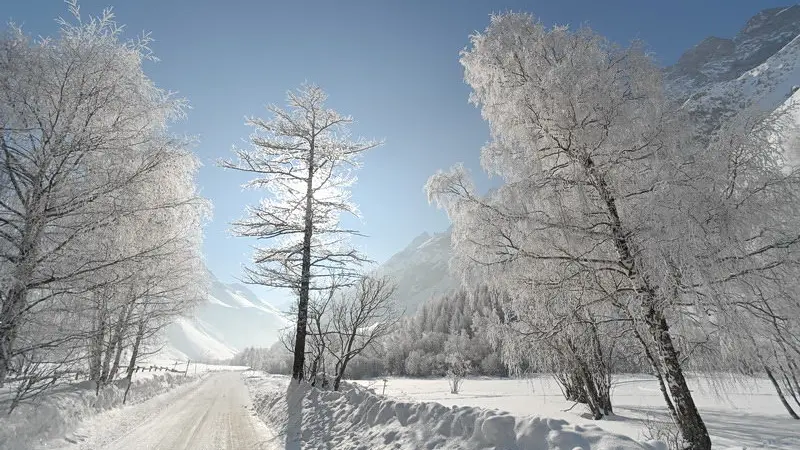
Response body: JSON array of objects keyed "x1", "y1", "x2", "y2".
[{"x1": 6, "y1": 365, "x2": 800, "y2": 450}]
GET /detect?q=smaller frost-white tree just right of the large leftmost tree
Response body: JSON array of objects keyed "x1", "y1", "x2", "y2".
[{"x1": 84, "y1": 143, "x2": 208, "y2": 394}]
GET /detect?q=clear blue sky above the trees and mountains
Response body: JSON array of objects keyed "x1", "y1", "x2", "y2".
[{"x1": 0, "y1": 0, "x2": 792, "y2": 303}]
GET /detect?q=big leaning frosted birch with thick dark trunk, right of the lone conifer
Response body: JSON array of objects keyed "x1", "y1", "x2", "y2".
[{"x1": 427, "y1": 14, "x2": 710, "y2": 450}]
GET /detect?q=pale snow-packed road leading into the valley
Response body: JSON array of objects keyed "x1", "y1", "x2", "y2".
[{"x1": 51, "y1": 372, "x2": 280, "y2": 450}]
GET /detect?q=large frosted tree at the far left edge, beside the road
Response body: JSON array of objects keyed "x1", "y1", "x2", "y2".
[{"x1": 0, "y1": 2, "x2": 200, "y2": 384}]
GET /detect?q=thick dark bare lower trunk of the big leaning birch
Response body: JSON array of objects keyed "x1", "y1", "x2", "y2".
[{"x1": 645, "y1": 306, "x2": 711, "y2": 450}]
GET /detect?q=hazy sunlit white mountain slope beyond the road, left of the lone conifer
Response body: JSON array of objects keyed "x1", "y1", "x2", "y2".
[{"x1": 162, "y1": 275, "x2": 289, "y2": 360}]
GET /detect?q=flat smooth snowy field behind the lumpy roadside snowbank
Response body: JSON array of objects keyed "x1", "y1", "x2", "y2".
[{"x1": 358, "y1": 376, "x2": 800, "y2": 449}]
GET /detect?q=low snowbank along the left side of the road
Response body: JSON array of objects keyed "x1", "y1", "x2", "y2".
[{"x1": 0, "y1": 373, "x2": 198, "y2": 450}]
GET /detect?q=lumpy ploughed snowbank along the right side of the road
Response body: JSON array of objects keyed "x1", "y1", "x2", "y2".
[{"x1": 245, "y1": 373, "x2": 666, "y2": 450}]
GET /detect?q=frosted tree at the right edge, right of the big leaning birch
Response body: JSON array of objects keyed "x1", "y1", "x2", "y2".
[{"x1": 681, "y1": 105, "x2": 800, "y2": 416}]
